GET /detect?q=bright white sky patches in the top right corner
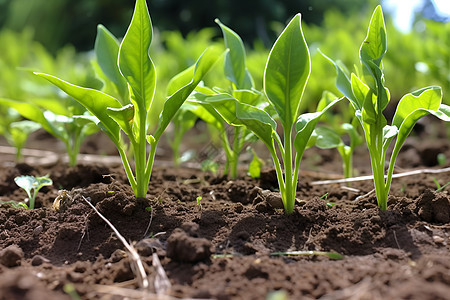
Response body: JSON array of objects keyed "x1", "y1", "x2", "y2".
[{"x1": 383, "y1": 0, "x2": 450, "y2": 32}]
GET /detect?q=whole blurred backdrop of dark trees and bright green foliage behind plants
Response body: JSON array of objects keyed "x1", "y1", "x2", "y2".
[{"x1": 0, "y1": 0, "x2": 450, "y2": 110}]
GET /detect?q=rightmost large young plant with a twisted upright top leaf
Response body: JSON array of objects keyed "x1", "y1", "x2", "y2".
[{"x1": 324, "y1": 6, "x2": 450, "y2": 210}]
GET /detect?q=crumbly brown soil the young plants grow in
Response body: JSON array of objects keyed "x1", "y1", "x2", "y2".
[{"x1": 0, "y1": 122, "x2": 450, "y2": 300}]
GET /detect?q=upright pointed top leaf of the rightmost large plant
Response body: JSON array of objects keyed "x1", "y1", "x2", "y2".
[{"x1": 359, "y1": 5, "x2": 387, "y2": 69}]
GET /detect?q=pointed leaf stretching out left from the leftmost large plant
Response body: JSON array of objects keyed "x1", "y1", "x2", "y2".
[{"x1": 34, "y1": 73, "x2": 122, "y2": 143}]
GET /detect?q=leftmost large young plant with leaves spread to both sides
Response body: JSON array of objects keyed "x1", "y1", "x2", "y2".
[{"x1": 36, "y1": 0, "x2": 219, "y2": 197}]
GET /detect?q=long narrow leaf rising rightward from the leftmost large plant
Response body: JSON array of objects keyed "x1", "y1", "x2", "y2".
[{"x1": 154, "y1": 47, "x2": 224, "y2": 140}]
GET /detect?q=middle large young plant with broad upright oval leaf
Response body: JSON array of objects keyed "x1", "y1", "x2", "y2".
[{"x1": 196, "y1": 14, "x2": 341, "y2": 213}]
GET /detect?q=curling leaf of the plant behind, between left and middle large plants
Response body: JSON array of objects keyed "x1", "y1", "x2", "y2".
[{"x1": 215, "y1": 19, "x2": 253, "y2": 89}]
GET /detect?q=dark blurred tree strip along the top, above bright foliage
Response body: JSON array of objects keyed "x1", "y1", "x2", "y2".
[{"x1": 0, "y1": 0, "x2": 377, "y2": 52}]
